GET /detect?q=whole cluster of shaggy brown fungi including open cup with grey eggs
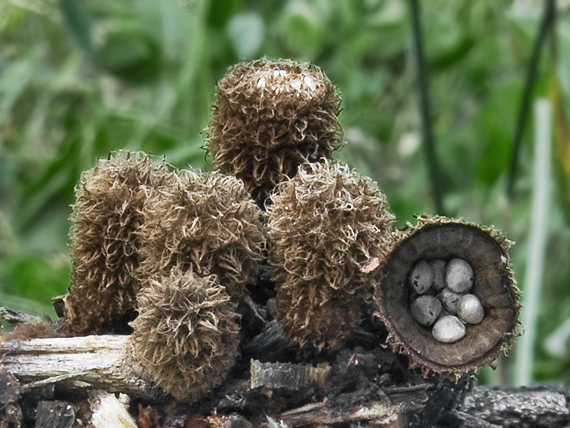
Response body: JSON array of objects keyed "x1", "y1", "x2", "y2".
[{"x1": 3, "y1": 59, "x2": 518, "y2": 426}]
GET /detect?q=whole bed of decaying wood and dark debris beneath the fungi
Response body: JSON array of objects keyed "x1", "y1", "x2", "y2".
[{"x1": 0, "y1": 312, "x2": 570, "y2": 428}]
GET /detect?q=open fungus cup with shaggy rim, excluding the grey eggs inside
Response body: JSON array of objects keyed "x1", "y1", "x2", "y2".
[{"x1": 375, "y1": 217, "x2": 519, "y2": 378}]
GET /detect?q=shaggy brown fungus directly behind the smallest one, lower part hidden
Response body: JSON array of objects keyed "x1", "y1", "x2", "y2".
[{"x1": 139, "y1": 171, "x2": 266, "y2": 298}]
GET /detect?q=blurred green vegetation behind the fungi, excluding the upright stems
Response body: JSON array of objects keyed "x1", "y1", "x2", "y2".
[{"x1": 0, "y1": 0, "x2": 570, "y2": 384}]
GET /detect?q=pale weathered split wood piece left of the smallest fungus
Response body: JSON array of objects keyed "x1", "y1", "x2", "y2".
[{"x1": 0, "y1": 335, "x2": 163, "y2": 400}]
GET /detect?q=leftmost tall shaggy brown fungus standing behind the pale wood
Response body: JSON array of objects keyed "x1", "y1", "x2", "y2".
[{"x1": 64, "y1": 151, "x2": 173, "y2": 335}]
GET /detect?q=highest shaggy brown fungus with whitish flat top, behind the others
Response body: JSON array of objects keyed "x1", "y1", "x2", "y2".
[{"x1": 208, "y1": 59, "x2": 342, "y2": 207}]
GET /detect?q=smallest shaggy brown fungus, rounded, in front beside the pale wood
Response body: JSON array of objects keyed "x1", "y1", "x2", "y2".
[{"x1": 130, "y1": 268, "x2": 239, "y2": 402}]
